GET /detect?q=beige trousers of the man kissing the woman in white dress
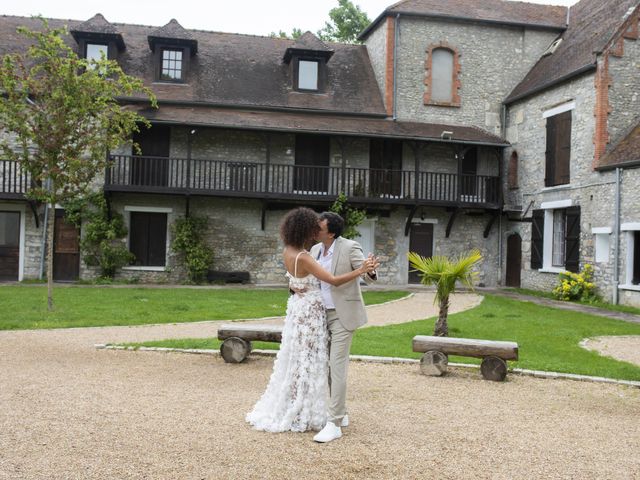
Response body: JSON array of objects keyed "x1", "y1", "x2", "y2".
[{"x1": 327, "y1": 310, "x2": 353, "y2": 426}]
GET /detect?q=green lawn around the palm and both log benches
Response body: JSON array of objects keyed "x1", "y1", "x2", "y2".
[{"x1": 139, "y1": 295, "x2": 640, "y2": 381}]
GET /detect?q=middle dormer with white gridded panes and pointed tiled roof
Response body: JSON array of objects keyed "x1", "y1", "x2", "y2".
[{"x1": 147, "y1": 19, "x2": 198, "y2": 83}]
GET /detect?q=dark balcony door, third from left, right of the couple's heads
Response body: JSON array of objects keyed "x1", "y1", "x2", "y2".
[{"x1": 369, "y1": 139, "x2": 402, "y2": 198}]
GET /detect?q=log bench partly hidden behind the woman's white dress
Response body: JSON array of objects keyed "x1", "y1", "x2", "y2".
[{"x1": 218, "y1": 324, "x2": 282, "y2": 363}]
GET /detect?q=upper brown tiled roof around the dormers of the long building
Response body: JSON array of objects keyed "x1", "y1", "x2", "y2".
[{"x1": 0, "y1": 16, "x2": 386, "y2": 116}]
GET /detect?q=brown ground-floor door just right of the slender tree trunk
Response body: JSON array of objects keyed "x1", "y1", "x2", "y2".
[{"x1": 53, "y1": 209, "x2": 80, "y2": 282}]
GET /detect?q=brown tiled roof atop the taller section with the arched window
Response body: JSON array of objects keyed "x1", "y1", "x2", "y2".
[{"x1": 360, "y1": 0, "x2": 567, "y2": 38}]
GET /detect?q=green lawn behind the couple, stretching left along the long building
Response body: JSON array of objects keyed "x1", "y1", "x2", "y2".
[{"x1": 0, "y1": 286, "x2": 407, "y2": 330}]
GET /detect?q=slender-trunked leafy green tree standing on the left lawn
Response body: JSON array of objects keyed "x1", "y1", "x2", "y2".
[{"x1": 0, "y1": 19, "x2": 156, "y2": 310}]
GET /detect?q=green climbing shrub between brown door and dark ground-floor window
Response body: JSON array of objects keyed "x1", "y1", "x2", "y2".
[{"x1": 64, "y1": 192, "x2": 135, "y2": 279}]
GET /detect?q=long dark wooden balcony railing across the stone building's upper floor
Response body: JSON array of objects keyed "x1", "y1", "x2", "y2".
[{"x1": 105, "y1": 155, "x2": 500, "y2": 207}]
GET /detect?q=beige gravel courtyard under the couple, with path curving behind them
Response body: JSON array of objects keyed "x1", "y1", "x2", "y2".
[{"x1": 0, "y1": 294, "x2": 640, "y2": 479}]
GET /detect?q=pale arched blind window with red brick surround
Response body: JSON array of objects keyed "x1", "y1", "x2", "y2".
[{"x1": 424, "y1": 42, "x2": 460, "y2": 107}]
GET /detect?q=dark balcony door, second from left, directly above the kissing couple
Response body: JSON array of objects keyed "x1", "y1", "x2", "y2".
[{"x1": 293, "y1": 135, "x2": 330, "y2": 193}]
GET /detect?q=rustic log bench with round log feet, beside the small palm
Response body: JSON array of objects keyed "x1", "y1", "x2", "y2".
[{"x1": 413, "y1": 335, "x2": 518, "y2": 381}]
